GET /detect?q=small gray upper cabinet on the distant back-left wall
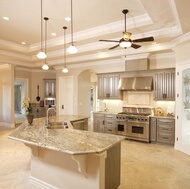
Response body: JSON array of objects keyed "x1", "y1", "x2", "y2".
[{"x1": 44, "y1": 79, "x2": 56, "y2": 97}]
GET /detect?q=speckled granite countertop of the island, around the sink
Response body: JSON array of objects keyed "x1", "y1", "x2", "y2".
[{"x1": 8, "y1": 115, "x2": 124, "y2": 154}]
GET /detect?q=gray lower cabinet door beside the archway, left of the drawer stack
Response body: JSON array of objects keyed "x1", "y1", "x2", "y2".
[{"x1": 93, "y1": 113, "x2": 104, "y2": 133}]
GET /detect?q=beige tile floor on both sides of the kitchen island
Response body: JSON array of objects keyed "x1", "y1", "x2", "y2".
[{"x1": 0, "y1": 127, "x2": 190, "y2": 189}]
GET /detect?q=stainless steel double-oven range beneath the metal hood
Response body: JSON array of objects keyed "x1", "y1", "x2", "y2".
[{"x1": 116, "y1": 107, "x2": 154, "y2": 142}]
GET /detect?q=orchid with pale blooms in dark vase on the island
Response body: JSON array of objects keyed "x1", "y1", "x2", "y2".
[{"x1": 22, "y1": 97, "x2": 34, "y2": 125}]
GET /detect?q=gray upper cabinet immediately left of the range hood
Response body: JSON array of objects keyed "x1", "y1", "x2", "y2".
[{"x1": 98, "y1": 74, "x2": 121, "y2": 99}]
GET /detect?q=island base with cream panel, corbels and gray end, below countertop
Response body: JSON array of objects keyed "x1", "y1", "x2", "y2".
[{"x1": 30, "y1": 143, "x2": 120, "y2": 189}]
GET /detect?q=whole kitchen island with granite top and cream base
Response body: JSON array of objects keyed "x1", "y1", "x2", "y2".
[{"x1": 8, "y1": 116, "x2": 124, "y2": 189}]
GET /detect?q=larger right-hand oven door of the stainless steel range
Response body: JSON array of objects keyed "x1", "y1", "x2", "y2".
[{"x1": 126, "y1": 121, "x2": 150, "y2": 142}]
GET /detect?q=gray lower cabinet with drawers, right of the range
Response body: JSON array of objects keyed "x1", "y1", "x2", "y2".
[{"x1": 150, "y1": 117, "x2": 175, "y2": 144}]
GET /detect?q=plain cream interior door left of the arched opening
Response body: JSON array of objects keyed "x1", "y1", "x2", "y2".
[{"x1": 58, "y1": 76, "x2": 73, "y2": 115}]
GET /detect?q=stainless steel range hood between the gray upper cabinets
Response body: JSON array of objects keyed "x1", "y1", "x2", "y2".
[{"x1": 118, "y1": 76, "x2": 153, "y2": 91}]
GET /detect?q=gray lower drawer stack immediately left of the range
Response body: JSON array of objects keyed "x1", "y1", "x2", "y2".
[{"x1": 104, "y1": 114, "x2": 116, "y2": 134}]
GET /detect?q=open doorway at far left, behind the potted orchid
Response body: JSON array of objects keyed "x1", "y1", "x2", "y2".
[{"x1": 14, "y1": 78, "x2": 28, "y2": 124}]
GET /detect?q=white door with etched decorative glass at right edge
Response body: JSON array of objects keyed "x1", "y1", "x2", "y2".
[{"x1": 175, "y1": 62, "x2": 190, "y2": 155}]
